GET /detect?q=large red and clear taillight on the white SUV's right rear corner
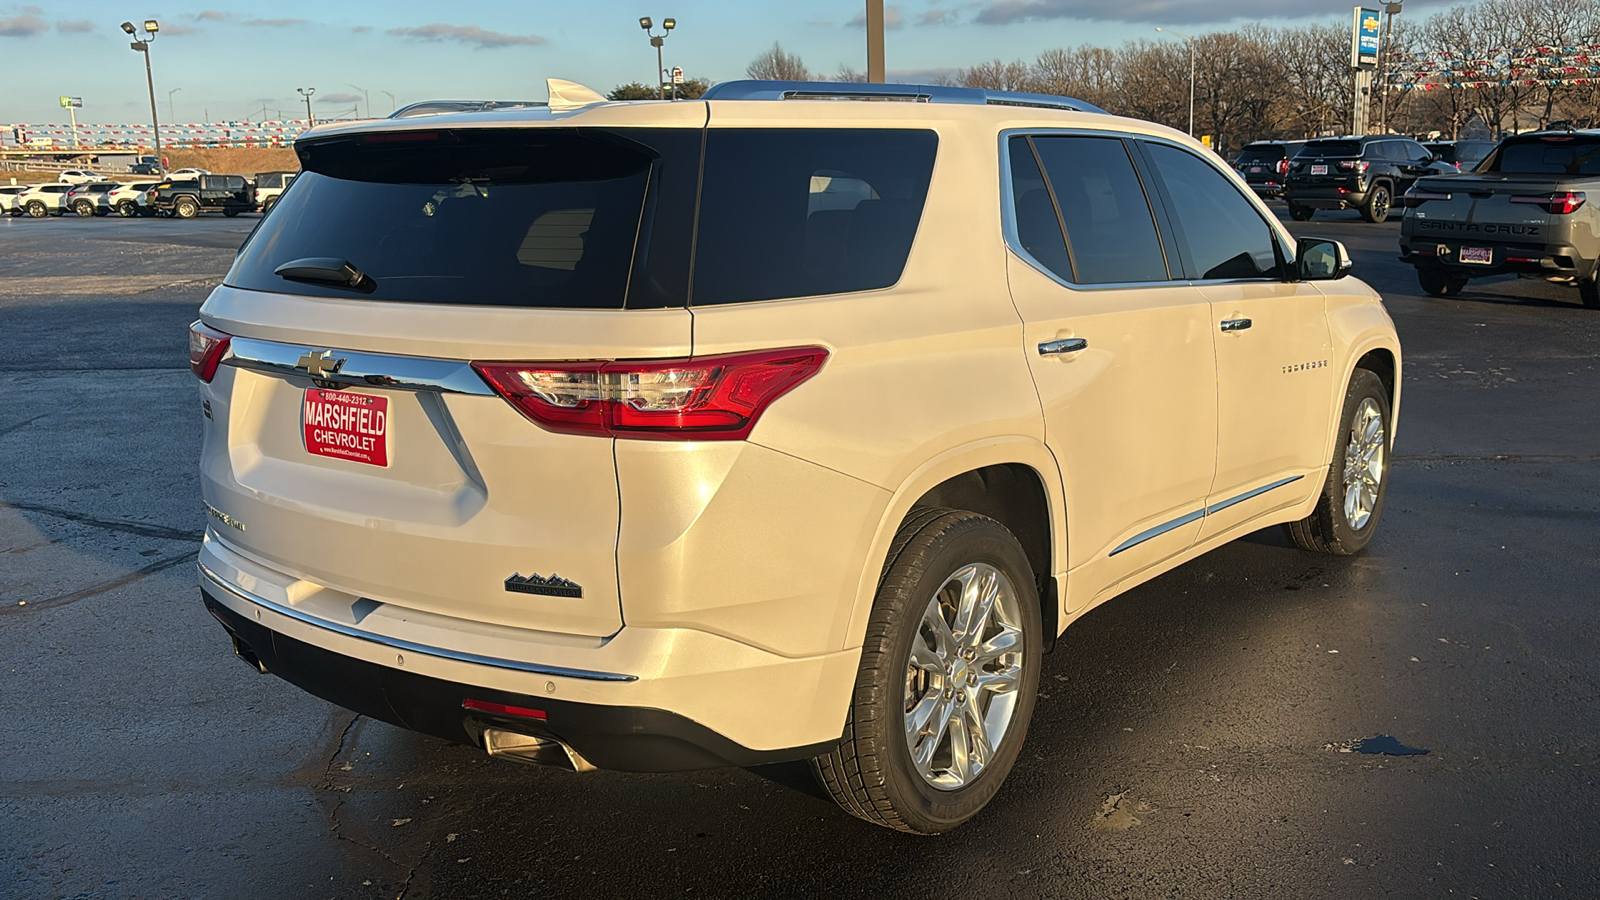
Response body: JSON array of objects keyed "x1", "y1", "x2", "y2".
[{"x1": 472, "y1": 348, "x2": 827, "y2": 440}]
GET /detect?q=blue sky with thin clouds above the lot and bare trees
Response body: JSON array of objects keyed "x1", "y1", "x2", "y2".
[{"x1": 0, "y1": 0, "x2": 1448, "y2": 123}]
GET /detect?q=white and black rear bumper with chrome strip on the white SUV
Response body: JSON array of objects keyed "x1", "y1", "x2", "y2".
[{"x1": 200, "y1": 536, "x2": 859, "y2": 772}]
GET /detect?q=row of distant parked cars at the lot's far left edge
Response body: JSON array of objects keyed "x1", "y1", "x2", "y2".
[{"x1": 0, "y1": 170, "x2": 296, "y2": 219}]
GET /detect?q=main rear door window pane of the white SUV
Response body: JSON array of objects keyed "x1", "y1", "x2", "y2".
[{"x1": 1019, "y1": 135, "x2": 1168, "y2": 285}]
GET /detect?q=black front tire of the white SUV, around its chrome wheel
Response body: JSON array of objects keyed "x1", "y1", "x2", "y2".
[{"x1": 1286, "y1": 368, "x2": 1394, "y2": 556}]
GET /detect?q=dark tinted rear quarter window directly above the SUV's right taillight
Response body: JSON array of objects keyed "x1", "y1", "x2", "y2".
[{"x1": 693, "y1": 128, "x2": 938, "y2": 306}]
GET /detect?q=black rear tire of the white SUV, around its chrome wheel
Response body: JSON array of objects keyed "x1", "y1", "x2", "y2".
[{"x1": 811, "y1": 509, "x2": 1043, "y2": 834}]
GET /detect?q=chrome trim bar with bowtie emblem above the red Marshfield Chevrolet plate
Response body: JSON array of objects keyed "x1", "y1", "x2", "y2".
[{"x1": 221, "y1": 338, "x2": 494, "y2": 397}]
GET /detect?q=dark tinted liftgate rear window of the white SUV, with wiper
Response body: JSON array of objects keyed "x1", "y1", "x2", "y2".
[{"x1": 226, "y1": 128, "x2": 701, "y2": 309}]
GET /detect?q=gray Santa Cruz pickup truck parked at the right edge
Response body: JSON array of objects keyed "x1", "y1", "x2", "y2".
[{"x1": 1400, "y1": 131, "x2": 1600, "y2": 309}]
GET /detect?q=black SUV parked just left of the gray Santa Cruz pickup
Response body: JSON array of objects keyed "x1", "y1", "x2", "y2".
[{"x1": 1283, "y1": 135, "x2": 1456, "y2": 223}]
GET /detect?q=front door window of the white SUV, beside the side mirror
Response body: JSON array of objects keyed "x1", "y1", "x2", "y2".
[{"x1": 1146, "y1": 143, "x2": 1278, "y2": 279}]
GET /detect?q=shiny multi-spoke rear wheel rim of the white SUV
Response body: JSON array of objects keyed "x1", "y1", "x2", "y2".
[{"x1": 904, "y1": 562, "x2": 1024, "y2": 791}]
